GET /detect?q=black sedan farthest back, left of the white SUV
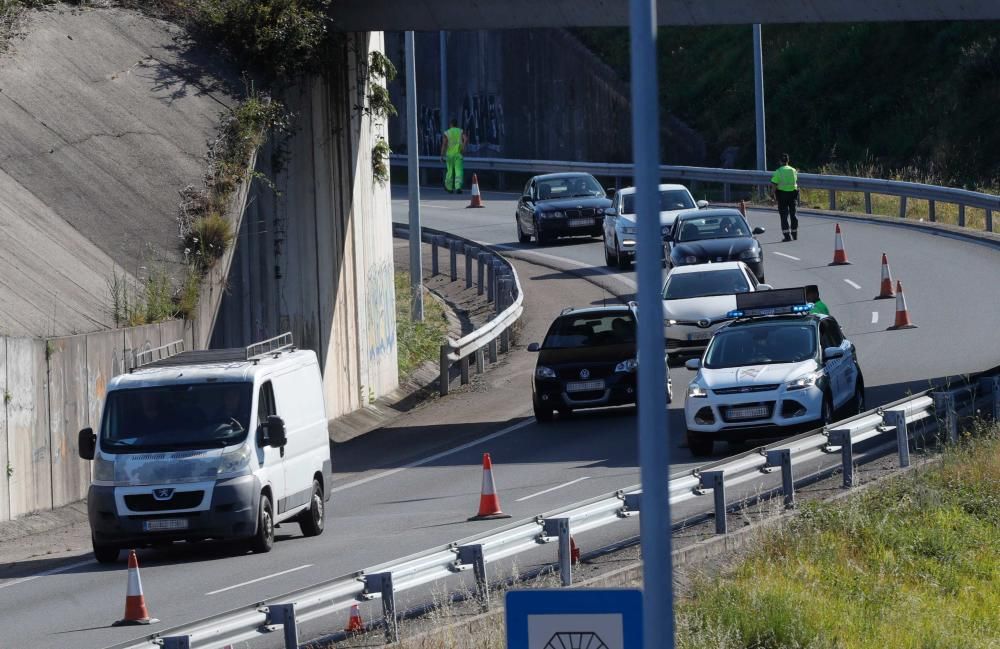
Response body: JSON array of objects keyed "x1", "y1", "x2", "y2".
[{"x1": 514, "y1": 173, "x2": 611, "y2": 245}]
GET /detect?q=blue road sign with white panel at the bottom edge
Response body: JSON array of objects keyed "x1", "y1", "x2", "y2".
[{"x1": 506, "y1": 589, "x2": 642, "y2": 649}]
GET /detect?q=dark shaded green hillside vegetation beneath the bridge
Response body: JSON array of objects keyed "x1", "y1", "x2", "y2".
[{"x1": 577, "y1": 22, "x2": 1000, "y2": 186}]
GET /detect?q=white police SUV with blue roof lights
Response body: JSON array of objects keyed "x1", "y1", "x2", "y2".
[{"x1": 684, "y1": 287, "x2": 865, "y2": 456}]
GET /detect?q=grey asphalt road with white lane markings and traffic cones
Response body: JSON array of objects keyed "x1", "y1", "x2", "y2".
[{"x1": 0, "y1": 185, "x2": 1000, "y2": 649}]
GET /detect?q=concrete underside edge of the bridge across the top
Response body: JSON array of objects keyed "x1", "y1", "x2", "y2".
[{"x1": 333, "y1": 0, "x2": 1000, "y2": 31}]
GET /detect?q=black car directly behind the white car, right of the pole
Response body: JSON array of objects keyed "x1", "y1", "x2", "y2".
[{"x1": 667, "y1": 208, "x2": 764, "y2": 282}]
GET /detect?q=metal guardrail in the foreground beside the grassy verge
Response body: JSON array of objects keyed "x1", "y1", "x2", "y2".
[{"x1": 110, "y1": 368, "x2": 1000, "y2": 649}]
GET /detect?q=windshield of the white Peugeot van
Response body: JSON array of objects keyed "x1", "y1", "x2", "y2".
[{"x1": 101, "y1": 382, "x2": 253, "y2": 453}]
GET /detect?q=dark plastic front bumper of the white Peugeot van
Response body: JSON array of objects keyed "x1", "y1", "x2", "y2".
[{"x1": 87, "y1": 475, "x2": 261, "y2": 547}]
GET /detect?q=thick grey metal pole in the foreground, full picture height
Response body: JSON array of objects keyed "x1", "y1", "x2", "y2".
[{"x1": 629, "y1": 0, "x2": 674, "y2": 649}]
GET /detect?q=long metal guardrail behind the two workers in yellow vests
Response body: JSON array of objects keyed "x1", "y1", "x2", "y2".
[{"x1": 390, "y1": 154, "x2": 1000, "y2": 232}]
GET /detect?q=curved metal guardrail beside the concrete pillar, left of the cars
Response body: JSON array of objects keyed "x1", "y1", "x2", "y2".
[{"x1": 392, "y1": 223, "x2": 524, "y2": 396}]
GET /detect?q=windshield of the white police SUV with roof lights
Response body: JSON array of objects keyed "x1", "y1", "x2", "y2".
[{"x1": 705, "y1": 322, "x2": 816, "y2": 369}]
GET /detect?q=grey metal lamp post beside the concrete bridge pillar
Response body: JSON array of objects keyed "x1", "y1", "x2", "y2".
[{"x1": 406, "y1": 32, "x2": 424, "y2": 322}]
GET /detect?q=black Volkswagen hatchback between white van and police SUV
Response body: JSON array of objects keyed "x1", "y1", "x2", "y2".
[{"x1": 528, "y1": 305, "x2": 670, "y2": 421}]
